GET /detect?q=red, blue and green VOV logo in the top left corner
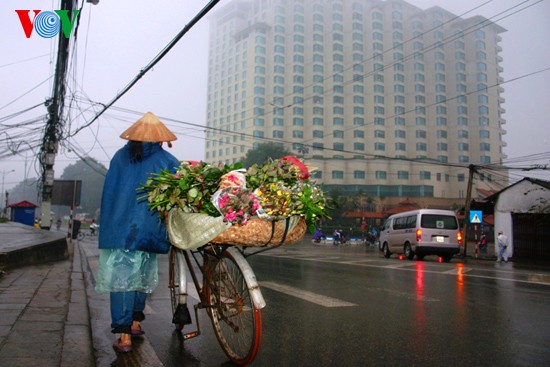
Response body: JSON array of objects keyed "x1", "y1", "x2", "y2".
[{"x1": 15, "y1": 10, "x2": 80, "y2": 38}]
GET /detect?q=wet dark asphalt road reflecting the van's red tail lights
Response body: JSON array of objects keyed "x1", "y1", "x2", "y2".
[{"x1": 82, "y1": 237, "x2": 550, "y2": 366}]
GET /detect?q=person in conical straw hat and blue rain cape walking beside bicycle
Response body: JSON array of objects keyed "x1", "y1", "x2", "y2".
[{"x1": 96, "y1": 112, "x2": 179, "y2": 352}]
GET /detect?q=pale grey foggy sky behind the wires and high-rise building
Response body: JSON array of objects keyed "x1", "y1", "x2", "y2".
[{"x1": 0, "y1": 0, "x2": 550, "y2": 189}]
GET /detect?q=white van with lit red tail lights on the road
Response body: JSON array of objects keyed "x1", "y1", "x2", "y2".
[{"x1": 380, "y1": 209, "x2": 462, "y2": 262}]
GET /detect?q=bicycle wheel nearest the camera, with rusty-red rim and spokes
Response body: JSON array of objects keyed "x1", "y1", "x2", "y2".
[{"x1": 205, "y1": 251, "x2": 262, "y2": 366}]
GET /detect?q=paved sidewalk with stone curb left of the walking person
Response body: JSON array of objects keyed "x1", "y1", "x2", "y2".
[{"x1": 0, "y1": 223, "x2": 95, "y2": 367}]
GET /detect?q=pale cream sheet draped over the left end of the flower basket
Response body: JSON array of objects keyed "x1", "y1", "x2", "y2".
[{"x1": 166, "y1": 208, "x2": 231, "y2": 250}]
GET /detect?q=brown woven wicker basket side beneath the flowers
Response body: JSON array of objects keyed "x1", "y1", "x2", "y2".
[{"x1": 210, "y1": 216, "x2": 307, "y2": 247}]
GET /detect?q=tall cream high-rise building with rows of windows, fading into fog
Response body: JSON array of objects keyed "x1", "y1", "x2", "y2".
[{"x1": 205, "y1": 0, "x2": 506, "y2": 205}]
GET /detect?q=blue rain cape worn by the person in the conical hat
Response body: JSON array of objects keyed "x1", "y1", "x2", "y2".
[{"x1": 99, "y1": 142, "x2": 179, "y2": 254}]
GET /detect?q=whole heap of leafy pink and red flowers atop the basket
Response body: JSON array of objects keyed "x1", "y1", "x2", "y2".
[{"x1": 138, "y1": 156, "x2": 328, "y2": 233}]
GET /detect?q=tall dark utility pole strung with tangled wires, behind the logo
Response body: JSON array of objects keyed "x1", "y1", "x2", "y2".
[{"x1": 38, "y1": 0, "x2": 77, "y2": 229}]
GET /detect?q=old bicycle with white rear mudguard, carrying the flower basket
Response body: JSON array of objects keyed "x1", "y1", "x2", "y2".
[{"x1": 169, "y1": 244, "x2": 267, "y2": 365}]
